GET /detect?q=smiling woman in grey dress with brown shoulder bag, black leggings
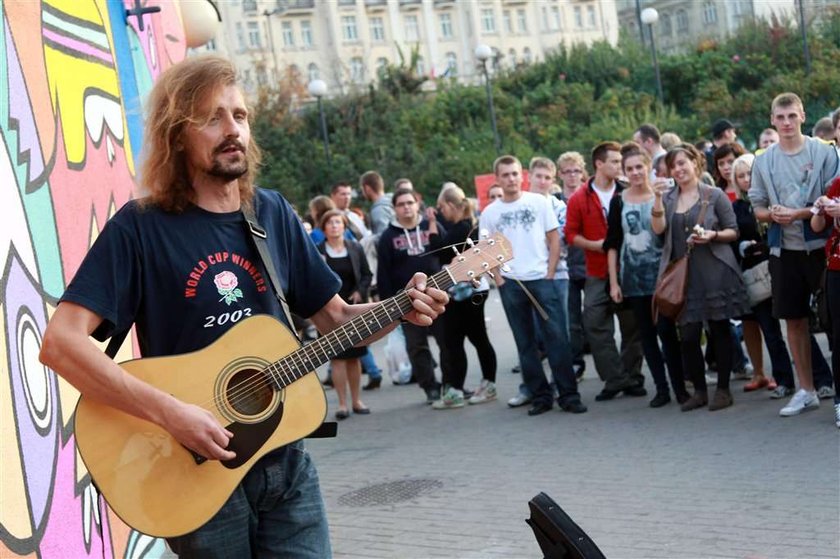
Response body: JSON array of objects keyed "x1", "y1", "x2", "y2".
[{"x1": 651, "y1": 144, "x2": 750, "y2": 411}]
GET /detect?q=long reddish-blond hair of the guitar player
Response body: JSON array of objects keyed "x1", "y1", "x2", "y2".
[{"x1": 140, "y1": 55, "x2": 262, "y2": 212}]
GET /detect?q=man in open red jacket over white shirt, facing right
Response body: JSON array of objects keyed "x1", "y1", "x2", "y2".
[{"x1": 566, "y1": 142, "x2": 647, "y2": 402}]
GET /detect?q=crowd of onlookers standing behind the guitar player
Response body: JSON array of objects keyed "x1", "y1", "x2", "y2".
[{"x1": 304, "y1": 93, "x2": 840, "y2": 434}]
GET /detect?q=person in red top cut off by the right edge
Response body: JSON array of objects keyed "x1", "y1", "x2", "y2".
[{"x1": 811, "y1": 175, "x2": 840, "y2": 428}]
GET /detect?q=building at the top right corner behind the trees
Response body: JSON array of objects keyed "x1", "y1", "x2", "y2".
[{"x1": 617, "y1": 0, "x2": 840, "y2": 53}]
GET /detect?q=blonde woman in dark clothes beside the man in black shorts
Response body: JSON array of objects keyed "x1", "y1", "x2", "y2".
[{"x1": 730, "y1": 153, "x2": 793, "y2": 398}]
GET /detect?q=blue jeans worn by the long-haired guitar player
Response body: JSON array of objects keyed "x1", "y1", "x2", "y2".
[{"x1": 167, "y1": 441, "x2": 332, "y2": 559}]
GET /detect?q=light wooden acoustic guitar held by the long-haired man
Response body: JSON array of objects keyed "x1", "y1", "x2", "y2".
[{"x1": 75, "y1": 235, "x2": 513, "y2": 537}]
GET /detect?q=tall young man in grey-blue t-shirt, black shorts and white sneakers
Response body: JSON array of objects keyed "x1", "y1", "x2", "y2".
[{"x1": 749, "y1": 93, "x2": 838, "y2": 417}]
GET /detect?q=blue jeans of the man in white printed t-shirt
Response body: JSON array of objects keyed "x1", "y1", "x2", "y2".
[{"x1": 499, "y1": 279, "x2": 580, "y2": 404}]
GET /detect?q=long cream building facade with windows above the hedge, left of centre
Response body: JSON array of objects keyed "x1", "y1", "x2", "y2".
[{"x1": 202, "y1": 0, "x2": 619, "y2": 95}]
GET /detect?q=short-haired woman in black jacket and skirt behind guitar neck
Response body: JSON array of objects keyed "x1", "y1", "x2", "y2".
[{"x1": 318, "y1": 210, "x2": 373, "y2": 420}]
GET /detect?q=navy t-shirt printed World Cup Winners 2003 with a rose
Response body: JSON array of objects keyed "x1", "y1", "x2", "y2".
[{"x1": 61, "y1": 188, "x2": 341, "y2": 357}]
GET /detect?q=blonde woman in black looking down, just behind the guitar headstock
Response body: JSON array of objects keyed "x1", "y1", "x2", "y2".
[{"x1": 426, "y1": 186, "x2": 496, "y2": 409}]
